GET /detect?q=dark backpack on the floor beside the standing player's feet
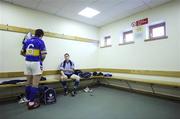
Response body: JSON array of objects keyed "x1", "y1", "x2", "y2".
[{"x1": 40, "y1": 86, "x2": 56, "y2": 104}]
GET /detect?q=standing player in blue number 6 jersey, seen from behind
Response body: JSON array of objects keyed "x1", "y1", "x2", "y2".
[{"x1": 21, "y1": 29, "x2": 47, "y2": 109}]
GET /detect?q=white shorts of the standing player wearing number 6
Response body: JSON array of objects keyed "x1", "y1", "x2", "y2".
[{"x1": 24, "y1": 61, "x2": 42, "y2": 75}]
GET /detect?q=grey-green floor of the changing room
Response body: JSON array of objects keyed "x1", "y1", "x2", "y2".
[{"x1": 0, "y1": 87, "x2": 180, "y2": 119}]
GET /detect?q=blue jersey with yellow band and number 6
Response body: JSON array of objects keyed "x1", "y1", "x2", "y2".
[{"x1": 22, "y1": 37, "x2": 47, "y2": 62}]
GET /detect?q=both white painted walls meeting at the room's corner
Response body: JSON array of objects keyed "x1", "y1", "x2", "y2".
[{"x1": 0, "y1": 0, "x2": 180, "y2": 72}]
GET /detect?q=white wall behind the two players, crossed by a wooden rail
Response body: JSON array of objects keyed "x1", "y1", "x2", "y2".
[{"x1": 0, "y1": 1, "x2": 98, "y2": 72}]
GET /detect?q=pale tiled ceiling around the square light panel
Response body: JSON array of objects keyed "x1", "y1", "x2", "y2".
[{"x1": 2, "y1": 0, "x2": 172, "y2": 27}]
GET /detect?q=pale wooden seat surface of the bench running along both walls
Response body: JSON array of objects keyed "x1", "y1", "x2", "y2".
[{"x1": 0, "y1": 73, "x2": 180, "y2": 101}]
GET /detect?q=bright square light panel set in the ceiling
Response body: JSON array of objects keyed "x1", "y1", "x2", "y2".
[{"x1": 78, "y1": 7, "x2": 100, "y2": 18}]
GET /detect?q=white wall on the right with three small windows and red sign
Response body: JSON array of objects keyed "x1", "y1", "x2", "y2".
[{"x1": 98, "y1": 0, "x2": 180, "y2": 71}]
